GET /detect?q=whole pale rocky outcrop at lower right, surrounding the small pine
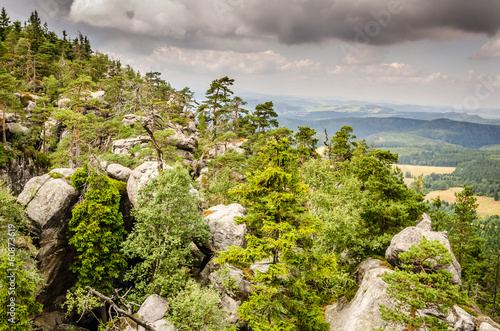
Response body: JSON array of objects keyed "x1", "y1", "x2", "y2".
[{"x1": 325, "y1": 214, "x2": 498, "y2": 331}]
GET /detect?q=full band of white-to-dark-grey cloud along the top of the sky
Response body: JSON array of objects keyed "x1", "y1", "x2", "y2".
[{"x1": 65, "y1": 0, "x2": 500, "y2": 49}]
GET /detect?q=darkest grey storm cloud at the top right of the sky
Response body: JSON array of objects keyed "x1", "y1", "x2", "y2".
[{"x1": 238, "y1": 0, "x2": 500, "y2": 45}]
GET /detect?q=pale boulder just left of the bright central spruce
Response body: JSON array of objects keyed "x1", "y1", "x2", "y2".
[{"x1": 203, "y1": 203, "x2": 247, "y2": 251}]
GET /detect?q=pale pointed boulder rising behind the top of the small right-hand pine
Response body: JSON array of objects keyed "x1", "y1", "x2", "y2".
[{"x1": 385, "y1": 214, "x2": 462, "y2": 286}]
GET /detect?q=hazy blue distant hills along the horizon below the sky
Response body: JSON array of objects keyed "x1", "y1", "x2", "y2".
[{"x1": 232, "y1": 94, "x2": 500, "y2": 149}]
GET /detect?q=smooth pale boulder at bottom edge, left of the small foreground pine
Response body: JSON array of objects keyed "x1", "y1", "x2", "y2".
[{"x1": 325, "y1": 259, "x2": 400, "y2": 331}]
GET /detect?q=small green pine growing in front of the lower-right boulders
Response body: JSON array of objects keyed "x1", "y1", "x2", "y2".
[{"x1": 380, "y1": 237, "x2": 466, "y2": 331}]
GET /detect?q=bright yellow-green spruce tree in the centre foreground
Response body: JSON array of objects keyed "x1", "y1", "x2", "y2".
[{"x1": 218, "y1": 138, "x2": 337, "y2": 330}]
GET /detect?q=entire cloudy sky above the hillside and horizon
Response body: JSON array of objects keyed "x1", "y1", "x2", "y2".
[{"x1": 0, "y1": 0, "x2": 500, "y2": 112}]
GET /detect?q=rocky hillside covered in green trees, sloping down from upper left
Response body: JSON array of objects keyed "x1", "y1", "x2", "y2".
[{"x1": 0, "y1": 10, "x2": 500, "y2": 331}]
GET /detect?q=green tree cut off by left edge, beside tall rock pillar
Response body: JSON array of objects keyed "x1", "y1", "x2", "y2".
[{"x1": 0, "y1": 182, "x2": 43, "y2": 331}]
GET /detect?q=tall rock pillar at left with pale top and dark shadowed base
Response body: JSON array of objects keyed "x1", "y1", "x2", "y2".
[{"x1": 17, "y1": 169, "x2": 79, "y2": 304}]
